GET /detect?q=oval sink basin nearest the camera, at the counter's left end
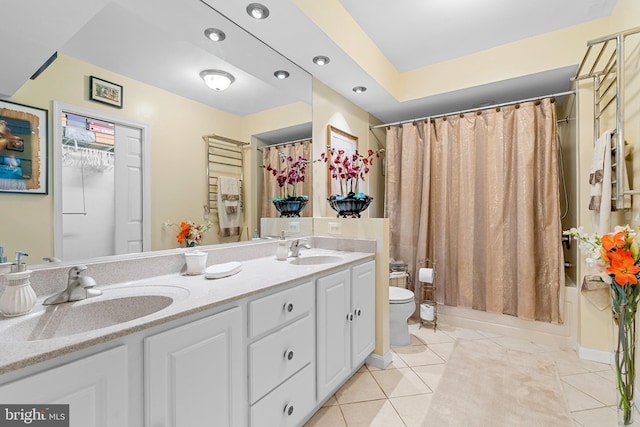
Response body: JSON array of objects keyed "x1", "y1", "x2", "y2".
[{"x1": 0, "y1": 285, "x2": 189, "y2": 342}]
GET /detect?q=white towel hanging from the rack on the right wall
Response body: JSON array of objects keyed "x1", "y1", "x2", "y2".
[{"x1": 589, "y1": 130, "x2": 614, "y2": 234}]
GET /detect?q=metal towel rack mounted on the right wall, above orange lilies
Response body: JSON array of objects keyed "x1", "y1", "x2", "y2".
[{"x1": 573, "y1": 27, "x2": 640, "y2": 210}]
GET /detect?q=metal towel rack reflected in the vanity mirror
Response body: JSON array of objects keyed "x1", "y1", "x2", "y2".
[{"x1": 202, "y1": 134, "x2": 251, "y2": 213}]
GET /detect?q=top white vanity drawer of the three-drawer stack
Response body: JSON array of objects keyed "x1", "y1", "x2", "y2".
[{"x1": 249, "y1": 282, "x2": 315, "y2": 338}]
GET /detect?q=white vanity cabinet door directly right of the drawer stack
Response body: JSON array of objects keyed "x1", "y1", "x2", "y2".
[{"x1": 316, "y1": 270, "x2": 353, "y2": 399}]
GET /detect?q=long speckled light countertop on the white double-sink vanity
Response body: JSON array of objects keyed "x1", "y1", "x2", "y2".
[{"x1": 0, "y1": 249, "x2": 374, "y2": 374}]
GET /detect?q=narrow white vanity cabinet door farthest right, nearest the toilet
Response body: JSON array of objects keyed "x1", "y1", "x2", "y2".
[{"x1": 351, "y1": 261, "x2": 376, "y2": 369}]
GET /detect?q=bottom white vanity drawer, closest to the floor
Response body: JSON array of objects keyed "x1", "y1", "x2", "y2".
[{"x1": 250, "y1": 364, "x2": 315, "y2": 427}]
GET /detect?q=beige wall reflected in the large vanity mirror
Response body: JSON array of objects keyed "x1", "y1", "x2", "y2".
[{"x1": 6, "y1": 55, "x2": 311, "y2": 263}]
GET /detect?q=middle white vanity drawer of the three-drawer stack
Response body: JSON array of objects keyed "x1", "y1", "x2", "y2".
[{"x1": 248, "y1": 315, "x2": 315, "y2": 403}]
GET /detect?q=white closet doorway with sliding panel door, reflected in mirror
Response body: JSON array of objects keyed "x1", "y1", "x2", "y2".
[{"x1": 52, "y1": 101, "x2": 151, "y2": 261}]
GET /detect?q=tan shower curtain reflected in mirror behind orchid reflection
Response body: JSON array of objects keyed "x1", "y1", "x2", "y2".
[{"x1": 260, "y1": 141, "x2": 313, "y2": 218}]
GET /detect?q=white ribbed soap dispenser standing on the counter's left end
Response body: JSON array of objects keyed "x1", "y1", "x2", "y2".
[{"x1": 0, "y1": 251, "x2": 37, "y2": 317}]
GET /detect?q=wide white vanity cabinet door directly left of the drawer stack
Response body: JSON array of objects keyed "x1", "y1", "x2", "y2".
[{"x1": 144, "y1": 307, "x2": 242, "y2": 427}]
